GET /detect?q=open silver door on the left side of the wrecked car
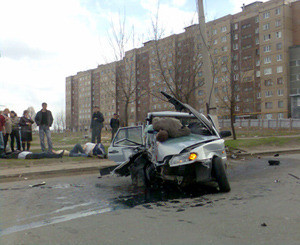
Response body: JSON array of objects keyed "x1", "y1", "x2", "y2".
[{"x1": 108, "y1": 126, "x2": 144, "y2": 164}]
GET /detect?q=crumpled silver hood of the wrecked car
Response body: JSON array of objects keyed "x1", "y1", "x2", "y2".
[{"x1": 157, "y1": 134, "x2": 219, "y2": 161}]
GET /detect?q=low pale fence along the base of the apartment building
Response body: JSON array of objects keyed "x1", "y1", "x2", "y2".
[{"x1": 219, "y1": 118, "x2": 300, "y2": 129}]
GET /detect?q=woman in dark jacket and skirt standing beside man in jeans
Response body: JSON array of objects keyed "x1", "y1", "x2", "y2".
[{"x1": 19, "y1": 110, "x2": 34, "y2": 151}]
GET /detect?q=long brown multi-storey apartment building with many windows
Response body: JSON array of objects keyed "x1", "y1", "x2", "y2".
[{"x1": 66, "y1": 0, "x2": 300, "y2": 130}]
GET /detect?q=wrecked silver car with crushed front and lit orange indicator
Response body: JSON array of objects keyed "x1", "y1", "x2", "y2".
[{"x1": 108, "y1": 92, "x2": 231, "y2": 192}]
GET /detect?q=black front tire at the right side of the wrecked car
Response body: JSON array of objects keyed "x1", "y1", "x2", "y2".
[{"x1": 212, "y1": 157, "x2": 230, "y2": 192}]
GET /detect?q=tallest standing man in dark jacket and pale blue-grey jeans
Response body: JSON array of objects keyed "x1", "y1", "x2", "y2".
[{"x1": 34, "y1": 102, "x2": 53, "y2": 153}]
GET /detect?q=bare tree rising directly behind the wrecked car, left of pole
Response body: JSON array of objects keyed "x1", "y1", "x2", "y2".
[{"x1": 150, "y1": 5, "x2": 204, "y2": 106}]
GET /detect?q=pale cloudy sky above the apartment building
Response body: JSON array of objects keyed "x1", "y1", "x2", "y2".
[{"x1": 0, "y1": 0, "x2": 268, "y2": 117}]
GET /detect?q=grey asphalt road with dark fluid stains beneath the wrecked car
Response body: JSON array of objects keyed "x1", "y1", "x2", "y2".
[{"x1": 0, "y1": 154, "x2": 300, "y2": 245}]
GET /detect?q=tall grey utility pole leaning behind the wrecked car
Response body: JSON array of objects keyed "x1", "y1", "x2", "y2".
[{"x1": 196, "y1": 0, "x2": 217, "y2": 115}]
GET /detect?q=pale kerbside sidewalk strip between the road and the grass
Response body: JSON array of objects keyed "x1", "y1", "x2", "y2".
[{"x1": 0, "y1": 148, "x2": 300, "y2": 183}]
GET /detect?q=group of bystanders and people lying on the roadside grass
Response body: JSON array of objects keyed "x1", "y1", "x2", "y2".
[{"x1": 0, "y1": 102, "x2": 120, "y2": 159}]
